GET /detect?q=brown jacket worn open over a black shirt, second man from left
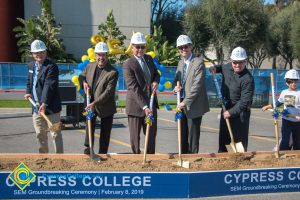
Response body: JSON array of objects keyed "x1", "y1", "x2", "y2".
[{"x1": 79, "y1": 62, "x2": 119, "y2": 118}]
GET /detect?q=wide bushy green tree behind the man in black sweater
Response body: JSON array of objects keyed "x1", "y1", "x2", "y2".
[{"x1": 184, "y1": 0, "x2": 267, "y2": 67}]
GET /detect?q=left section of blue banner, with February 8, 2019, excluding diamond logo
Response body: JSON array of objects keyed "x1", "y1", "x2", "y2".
[{"x1": 0, "y1": 172, "x2": 189, "y2": 199}]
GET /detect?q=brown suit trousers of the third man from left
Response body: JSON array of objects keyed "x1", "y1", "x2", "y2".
[{"x1": 128, "y1": 109, "x2": 157, "y2": 154}]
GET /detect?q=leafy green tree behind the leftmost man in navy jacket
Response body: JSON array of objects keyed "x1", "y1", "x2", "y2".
[{"x1": 13, "y1": 0, "x2": 75, "y2": 63}]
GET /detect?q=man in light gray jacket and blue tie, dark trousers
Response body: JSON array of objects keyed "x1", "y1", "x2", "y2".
[{"x1": 174, "y1": 35, "x2": 209, "y2": 153}]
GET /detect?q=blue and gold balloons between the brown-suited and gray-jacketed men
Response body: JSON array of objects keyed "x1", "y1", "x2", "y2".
[{"x1": 147, "y1": 51, "x2": 172, "y2": 92}]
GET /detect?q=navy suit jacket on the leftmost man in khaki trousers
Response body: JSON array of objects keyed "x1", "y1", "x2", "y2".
[{"x1": 26, "y1": 59, "x2": 61, "y2": 114}]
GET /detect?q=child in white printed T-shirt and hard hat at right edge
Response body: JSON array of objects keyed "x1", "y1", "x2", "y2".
[{"x1": 262, "y1": 69, "x2": 300, "y2": 150}]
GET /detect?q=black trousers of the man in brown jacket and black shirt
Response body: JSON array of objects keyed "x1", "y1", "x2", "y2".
[{"x1": 84, "y1": 115, "x2": 114, "y2": 154}]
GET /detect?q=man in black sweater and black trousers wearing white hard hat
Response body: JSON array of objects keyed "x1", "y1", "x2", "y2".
[{"x1": 210, "y1": 47, "x2": 254, "y2": 152}]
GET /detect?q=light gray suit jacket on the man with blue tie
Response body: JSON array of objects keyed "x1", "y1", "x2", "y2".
[{"x1": 173, "y1": 55, "x2": 209, "y2": 118}]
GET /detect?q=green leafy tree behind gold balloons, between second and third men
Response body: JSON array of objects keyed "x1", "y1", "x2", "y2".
[{"x1": 98, "y1": 10, "x2": 128, "y2": 63}]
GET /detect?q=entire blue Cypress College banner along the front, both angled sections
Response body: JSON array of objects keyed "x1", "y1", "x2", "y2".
[{"x1": 0, "y1": 168, "x2": 300, "y2": 199}]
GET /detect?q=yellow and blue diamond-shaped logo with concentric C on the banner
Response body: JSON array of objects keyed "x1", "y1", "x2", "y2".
[{"x1": 8, "y1": 162, "x2": 36, "y2": 190}]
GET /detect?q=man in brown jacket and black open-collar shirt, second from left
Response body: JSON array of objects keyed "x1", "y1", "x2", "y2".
[{"x1": 79, "y1": 42, "x2": 119, "y2": 154}]
